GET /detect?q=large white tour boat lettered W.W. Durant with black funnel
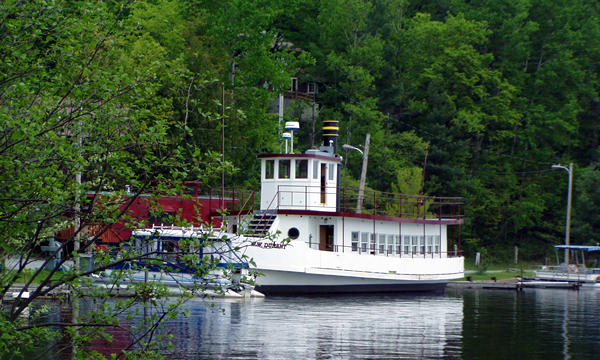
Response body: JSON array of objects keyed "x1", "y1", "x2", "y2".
[{"x1": 230, "y1": 121, "x2": 464, "y2": 294}]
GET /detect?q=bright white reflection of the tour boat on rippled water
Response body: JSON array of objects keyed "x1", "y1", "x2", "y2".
[{"x1": 151, "y1": 296, "x2": 463, "y2": 359}]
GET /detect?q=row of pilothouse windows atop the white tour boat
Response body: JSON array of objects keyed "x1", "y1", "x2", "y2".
[{"x1": 265, "y1": 159, "x2": 335, "y2": 180}]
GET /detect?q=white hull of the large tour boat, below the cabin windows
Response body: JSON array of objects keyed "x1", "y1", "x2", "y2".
[{"x1": 239, "y1": 236, "x2": 464, "y2": 295}]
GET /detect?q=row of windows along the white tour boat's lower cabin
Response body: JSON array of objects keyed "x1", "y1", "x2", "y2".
[{"x1": 352, "y1": 231, "x2": 441, "y2": 255}]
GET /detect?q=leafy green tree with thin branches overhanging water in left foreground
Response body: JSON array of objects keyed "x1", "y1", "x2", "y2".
[{"x1": 0, "y1": 0, "x2": 239, "y2": 359}]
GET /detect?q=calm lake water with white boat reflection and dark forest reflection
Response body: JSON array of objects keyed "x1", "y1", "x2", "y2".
[{"x1": 127, "y1": 289, "x2": 600, "y2": 359}]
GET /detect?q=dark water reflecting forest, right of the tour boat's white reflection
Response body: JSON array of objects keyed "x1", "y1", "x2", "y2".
[{"x1": 453, "y1": 289, "x2": 600, "y2": 359}]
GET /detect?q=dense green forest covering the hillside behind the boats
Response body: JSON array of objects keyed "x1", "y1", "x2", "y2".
[{"x1": 0, "y1": 0, "x2": 600, "y2": 260}]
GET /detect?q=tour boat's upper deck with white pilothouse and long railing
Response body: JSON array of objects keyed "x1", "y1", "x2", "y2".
[{"x1": 259, "y1": 148, "x2": 464, "y2": 224}]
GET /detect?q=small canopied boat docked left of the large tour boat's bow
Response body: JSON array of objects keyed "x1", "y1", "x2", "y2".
[{"x1": 94, "y1": 225, "x2": 264, "y2": 298}]
